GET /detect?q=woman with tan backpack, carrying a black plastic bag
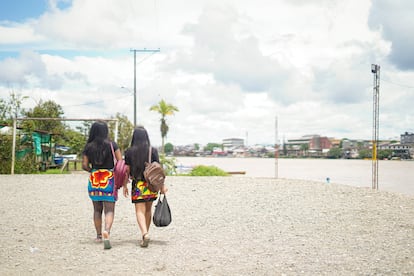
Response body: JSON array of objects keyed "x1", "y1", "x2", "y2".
[{"x1": 124, "y1": 126, "x2": 167, "y2": 247}]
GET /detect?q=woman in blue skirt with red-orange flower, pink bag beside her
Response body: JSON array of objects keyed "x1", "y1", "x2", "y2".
[{"x1": 82, "y1": 122, "x2": 126, "y2": 249}]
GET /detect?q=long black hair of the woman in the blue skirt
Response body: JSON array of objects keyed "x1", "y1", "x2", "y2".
[{"x1": 85, "y1": 121, "x2": 112, "y2": 165}]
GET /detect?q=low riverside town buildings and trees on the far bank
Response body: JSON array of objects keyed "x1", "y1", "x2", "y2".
[{"x1": 170, "y1": 132, "x2": 414, "y2": 160}]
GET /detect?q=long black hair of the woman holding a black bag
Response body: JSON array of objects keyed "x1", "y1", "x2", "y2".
[{"x1": 128, "y1": 126, "x2": 151, "y2": 178}]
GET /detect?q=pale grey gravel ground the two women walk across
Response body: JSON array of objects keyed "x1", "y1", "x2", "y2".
[{"x1": 0, "y1": 173, "x2": 414, "y2": 275}]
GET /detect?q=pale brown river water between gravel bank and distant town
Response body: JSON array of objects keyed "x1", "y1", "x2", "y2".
[{"x1": 176, "y1": 157, "x2": 414, "y2": 195}]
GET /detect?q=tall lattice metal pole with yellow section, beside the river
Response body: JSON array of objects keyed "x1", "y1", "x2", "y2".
[{"x1": 371, "y1": 64, "x2": 380, "y2": 190}]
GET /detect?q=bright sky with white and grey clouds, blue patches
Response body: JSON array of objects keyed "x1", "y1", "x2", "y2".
[{"x1": 0, "y1": 0, "x2": 414, "y2": 145}]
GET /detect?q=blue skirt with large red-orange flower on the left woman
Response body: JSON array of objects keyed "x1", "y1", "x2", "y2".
[{"x1": 88, "y1": 169, "x2": 118, "y2": 202}]
